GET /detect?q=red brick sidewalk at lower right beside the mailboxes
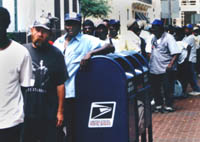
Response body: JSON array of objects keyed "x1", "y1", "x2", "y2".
[{"x1": 152, "y1": 96, "x2": 200, "y2": 142}]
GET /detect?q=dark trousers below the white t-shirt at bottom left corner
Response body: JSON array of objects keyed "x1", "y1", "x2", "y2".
[{"x1": 0, "y1": 124, "x2": 21, "y2": 142}]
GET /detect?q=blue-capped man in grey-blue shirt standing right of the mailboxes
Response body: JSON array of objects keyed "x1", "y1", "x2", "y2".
[{"x1": 149, "y1": 19, "x2": 181, "y2": 112}]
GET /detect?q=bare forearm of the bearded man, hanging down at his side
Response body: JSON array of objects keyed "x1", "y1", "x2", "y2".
[{"x1": 56, "y1": 84, "x2": 65, "y2": 127}]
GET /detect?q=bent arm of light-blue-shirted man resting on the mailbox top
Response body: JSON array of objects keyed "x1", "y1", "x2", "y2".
[{"x1": 80, "y1": 44, "x2": 115, "y2": 68}]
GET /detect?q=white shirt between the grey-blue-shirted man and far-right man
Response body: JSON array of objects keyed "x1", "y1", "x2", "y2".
[{"x1": 176, "y1": 41, "x2": 188, "y2": 64}]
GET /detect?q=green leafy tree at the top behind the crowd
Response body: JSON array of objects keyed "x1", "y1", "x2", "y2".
[{"x1": 80, "y1": 0, "x2": 111, "y2": 20}]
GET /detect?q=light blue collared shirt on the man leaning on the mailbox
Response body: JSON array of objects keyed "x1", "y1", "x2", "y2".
[{"x1": 54, "y1": 33, "x2": 102, "y2": 98}]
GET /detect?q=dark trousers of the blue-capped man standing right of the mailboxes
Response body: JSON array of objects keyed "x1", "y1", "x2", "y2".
[{"x1": 150, "y1": 71, "x2": 174, "y2": 107}]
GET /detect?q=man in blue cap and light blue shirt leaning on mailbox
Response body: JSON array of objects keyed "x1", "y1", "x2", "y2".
[{"x1": 54, "y1": 13, "x2": 114, "y2": 142}]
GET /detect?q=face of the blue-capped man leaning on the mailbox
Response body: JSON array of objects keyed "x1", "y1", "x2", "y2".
[{"x1": 65, "y1": 21, "x2": 81, "y2": 37}]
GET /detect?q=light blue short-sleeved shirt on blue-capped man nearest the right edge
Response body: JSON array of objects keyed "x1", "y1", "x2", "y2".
[{"x1": 183, "y1": 34, "x2": 197, "y2": 63}]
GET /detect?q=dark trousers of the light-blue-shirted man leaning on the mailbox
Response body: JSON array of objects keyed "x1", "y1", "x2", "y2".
[{"x1": 64, "y1": 98, "x2": 75, "y2": 142}]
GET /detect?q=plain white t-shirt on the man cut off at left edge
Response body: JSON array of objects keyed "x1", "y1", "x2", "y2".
[{"x1": 0, "y1": 41, "x2": 32, "y2": 129}]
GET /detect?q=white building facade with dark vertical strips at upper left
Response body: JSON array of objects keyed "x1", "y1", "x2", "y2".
[{"x1": 0, "y1": 0, "x2": 80, "y2": 32}]
